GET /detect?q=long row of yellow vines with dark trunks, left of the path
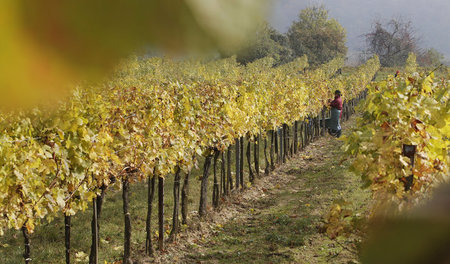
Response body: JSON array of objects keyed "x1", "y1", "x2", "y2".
[{"x1": 0, "y1": 54, "x2": 379, "y2": 263}]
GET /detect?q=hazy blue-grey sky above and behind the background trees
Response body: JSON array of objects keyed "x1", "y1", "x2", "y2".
[{"x1": 269, "y1": 0, "x2": 450, "y2": 58}]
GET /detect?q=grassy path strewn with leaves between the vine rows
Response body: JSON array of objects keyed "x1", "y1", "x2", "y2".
[{"x1": 149, "y1": 116, "x2": 370, "y2": 263}]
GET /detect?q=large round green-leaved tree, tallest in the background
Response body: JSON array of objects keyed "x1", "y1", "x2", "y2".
[{"x1": 287, "y1": 5, "x2": 347, "y2": 65}]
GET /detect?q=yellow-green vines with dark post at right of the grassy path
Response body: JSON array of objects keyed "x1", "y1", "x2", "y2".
[{"x1": 345, "y1": 54, "x2": 450, "y2": 212}]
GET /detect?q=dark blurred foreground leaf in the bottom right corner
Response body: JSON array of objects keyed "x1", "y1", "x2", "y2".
[{"x1": 361, "y1": 184, "x2": 450, "y2": 264}]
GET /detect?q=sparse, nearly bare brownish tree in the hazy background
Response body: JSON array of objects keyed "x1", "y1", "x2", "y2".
[{"x1": 364, "y1": 18, "x2": 419, "y2": 67}]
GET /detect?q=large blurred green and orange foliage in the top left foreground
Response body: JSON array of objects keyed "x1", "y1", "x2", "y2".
[{"x1": 0, "y1": 0, "x2": 265, "y2": 108}]
